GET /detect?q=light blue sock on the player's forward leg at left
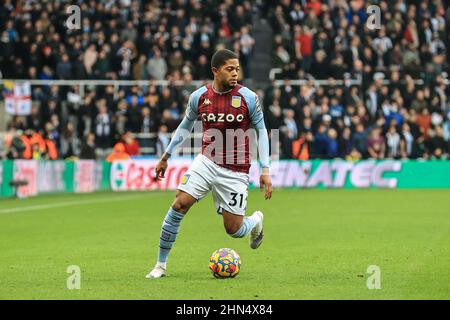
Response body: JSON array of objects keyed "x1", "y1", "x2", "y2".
[{"x1": 158, "y1": 207, "x2": 184, "y2": 262}]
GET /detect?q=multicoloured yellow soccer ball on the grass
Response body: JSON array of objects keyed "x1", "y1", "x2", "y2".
[{"x1": 209, "y1": 248, "x2": 241, "y2": 279}]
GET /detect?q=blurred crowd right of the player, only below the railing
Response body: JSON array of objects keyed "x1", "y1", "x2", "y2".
[{"x1": 261, "y1": 78, "x2": 450, "y2": 161}]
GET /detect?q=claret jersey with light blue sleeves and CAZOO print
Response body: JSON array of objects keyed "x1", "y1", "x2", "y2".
[{"x1": 167, "y1": 84, "x2": 269, "y2": 173}]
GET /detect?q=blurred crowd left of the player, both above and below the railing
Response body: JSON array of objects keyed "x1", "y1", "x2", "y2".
[{"x1": 0, "y1": 0, "x2": 254, "y2": 158}]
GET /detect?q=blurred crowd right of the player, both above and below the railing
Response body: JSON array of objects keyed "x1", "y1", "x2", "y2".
[{"x1": 265, "y1": 0, "x2": 450, "y2": 159}]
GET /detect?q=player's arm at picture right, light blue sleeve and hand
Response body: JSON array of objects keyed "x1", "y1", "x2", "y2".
[{"x1": 250, "y1": 96, "x2": 272, "y2": 200}]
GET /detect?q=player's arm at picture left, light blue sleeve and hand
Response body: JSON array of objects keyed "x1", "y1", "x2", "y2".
[{"x1": 155, "y1": 95, "x2": 198, "y2": 180}]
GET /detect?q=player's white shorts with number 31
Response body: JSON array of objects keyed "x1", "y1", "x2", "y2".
[{"x1": 178, "y1": 154, "x2": 250, "y2": 216}]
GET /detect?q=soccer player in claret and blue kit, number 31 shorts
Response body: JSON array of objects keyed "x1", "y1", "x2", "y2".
[{"x1": 146, "y1": 50, "x2": 272, "y2": 279}]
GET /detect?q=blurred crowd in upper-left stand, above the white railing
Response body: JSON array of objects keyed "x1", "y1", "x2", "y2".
[{"x1": 0, "y1": 0, "x2": 254, "y2": 80}]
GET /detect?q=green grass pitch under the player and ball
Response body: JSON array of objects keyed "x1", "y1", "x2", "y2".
[{"x1": 0, "y1": 190, "x2": 450, "y2": 300}]
